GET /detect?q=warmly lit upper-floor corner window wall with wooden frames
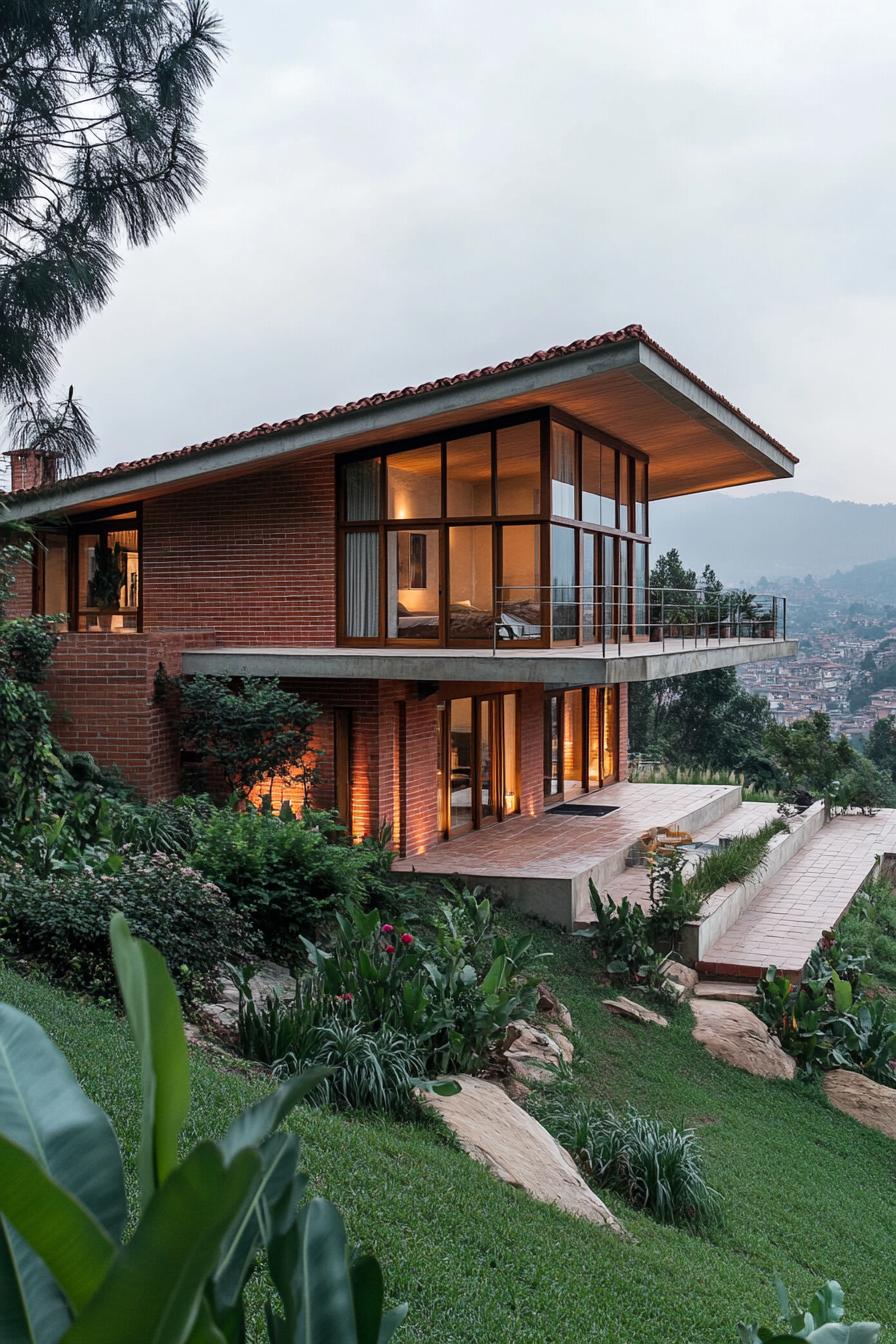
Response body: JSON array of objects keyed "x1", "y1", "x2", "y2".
[{"x1": 340, "y1": 410, "x2": 647, "y2": 646}]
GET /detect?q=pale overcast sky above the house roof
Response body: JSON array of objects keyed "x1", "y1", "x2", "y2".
[{"x1": 62, "y1": 0, "x2": 896, "y2": 501}]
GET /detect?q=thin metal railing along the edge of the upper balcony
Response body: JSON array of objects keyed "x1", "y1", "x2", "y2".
[{"x1": 492, "y1": 583, "x2": 787, "y2": 655}]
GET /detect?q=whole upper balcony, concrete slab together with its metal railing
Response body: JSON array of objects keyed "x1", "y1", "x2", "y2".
[{"x1": 183, "y1": 585, "x2": 797, "y2": 685}]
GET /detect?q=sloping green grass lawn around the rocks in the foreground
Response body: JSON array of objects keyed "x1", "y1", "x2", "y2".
[{"x1": 0, "y1": 913, "x2": 896, "y2": 1344}]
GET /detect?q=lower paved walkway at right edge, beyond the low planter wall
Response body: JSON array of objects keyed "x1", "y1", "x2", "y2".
[{"x1": 700, "y1": 809, "x2": 896, "y2": 978}]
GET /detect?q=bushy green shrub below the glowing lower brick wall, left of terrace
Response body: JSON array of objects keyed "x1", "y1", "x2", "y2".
[{"x1": 191, "y1": 808, "x2": 368, "y2": 960}]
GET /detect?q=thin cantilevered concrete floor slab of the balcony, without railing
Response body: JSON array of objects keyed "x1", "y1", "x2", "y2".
[{"x1": 183, "y1": 640, "x2": 798, "y2": 685}]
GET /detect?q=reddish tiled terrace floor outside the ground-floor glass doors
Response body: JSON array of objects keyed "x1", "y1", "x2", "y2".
[{"x1": 394, "y1": 782, "x2": 735, "y2": 878}]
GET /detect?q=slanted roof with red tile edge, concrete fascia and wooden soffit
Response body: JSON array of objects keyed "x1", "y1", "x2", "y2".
[{"x1": 5, "y1": 325, "x2": 798, "y2": 517}]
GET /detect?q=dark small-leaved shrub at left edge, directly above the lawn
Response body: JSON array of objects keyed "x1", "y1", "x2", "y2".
[{"x1": 0, "y1": 851, "x2": 257, "y2": 999}]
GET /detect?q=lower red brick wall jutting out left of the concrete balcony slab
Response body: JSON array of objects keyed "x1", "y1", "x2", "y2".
[{"x1": 46, "y1": 630, "x2": 214, "y2": 801}]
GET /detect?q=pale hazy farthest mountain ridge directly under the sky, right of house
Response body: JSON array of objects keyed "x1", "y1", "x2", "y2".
[{"x1": 650, "y1": 491, "x2": 896, "y2": 583}]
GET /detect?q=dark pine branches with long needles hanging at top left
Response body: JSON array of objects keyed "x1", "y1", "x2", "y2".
[{"x1": 0, "y1": 0, "x2": 222, "y2": 470}]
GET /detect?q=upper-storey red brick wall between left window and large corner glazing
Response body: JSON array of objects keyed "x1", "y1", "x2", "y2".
[{"x1": 142, "y1": 456, "x2": 336, "y2": 646}]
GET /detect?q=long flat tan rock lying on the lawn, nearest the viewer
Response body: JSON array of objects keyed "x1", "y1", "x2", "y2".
[{"x1": 419, "y1": 1074, "x2": 625, "y2": 1235}]
